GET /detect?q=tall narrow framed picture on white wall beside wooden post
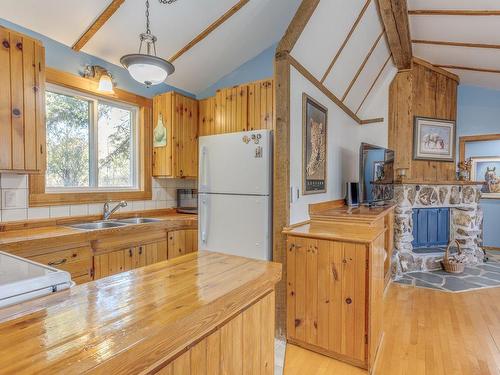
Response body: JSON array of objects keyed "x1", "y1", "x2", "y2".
[{"x1": 302, "y1": 93, "x2": 328, "y2": 194}]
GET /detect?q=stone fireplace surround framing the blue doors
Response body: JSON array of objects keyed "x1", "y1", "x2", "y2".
[{"x1": 392, "y1": 183, "x2": 484, "y2": 276}]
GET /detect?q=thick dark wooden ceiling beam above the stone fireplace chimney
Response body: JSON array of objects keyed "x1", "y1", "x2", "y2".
[{"x1": 378, "y1": 0, "x2": 412, "y2": 70}]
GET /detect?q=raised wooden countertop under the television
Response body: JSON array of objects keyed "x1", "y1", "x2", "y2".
[{"x1": 309, "y1": 205, "x2": 395, "y2": 224}]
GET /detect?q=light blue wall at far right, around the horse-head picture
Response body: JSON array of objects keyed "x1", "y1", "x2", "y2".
[{"x1": 457, "y1": 85, "x2": 500, "y2": 247}]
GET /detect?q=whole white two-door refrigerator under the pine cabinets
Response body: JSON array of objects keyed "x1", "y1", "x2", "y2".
[{"x1": 198, "y1": 130, "x2": 273, "y2": 260}]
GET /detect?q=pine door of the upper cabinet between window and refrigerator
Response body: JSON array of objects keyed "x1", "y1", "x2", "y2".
[{"x1": 173, "y1": 94, "x2": 198, "y2": 177}]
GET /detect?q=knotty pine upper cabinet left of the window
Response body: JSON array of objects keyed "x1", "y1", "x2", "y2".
[{"x1": 0, "y1": 27, "x2": 45, "y2": 173}]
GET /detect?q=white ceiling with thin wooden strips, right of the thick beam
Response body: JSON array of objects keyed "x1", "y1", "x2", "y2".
[{"x1": 408, "y1": 0, "x2": 500, "y2": 89}]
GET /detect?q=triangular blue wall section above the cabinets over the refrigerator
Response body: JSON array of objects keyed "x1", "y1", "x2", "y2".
[{"x1": 196, "y1": 44, "x2": 277, "y2": 99}]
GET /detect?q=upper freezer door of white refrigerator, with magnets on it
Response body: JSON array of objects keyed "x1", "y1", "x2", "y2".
[{"x1": 198, "y1": 130, "x2": 272, "y2": 195}]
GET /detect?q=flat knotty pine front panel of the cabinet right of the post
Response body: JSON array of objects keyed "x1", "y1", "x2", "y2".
[{"x1": 287, "y1": 237, "x2": 367, "y2": 362}]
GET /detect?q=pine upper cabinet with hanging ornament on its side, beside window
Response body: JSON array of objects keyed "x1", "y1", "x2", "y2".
[{"x1": 153, "y1": 92, "x2": 198, "y2": 178}]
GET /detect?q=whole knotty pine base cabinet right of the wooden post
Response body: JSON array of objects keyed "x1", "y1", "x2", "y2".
[{"x1": 287, "y1": 234, "x2": 385, "y2": 369}]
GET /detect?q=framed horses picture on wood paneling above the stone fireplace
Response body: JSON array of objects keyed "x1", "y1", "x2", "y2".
[{"x1": 413, "y1": 116, "x2": 455, "y2": 162}]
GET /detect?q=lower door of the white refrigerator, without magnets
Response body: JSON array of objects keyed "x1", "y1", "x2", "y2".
[{"x1": 198, "y1": 194, "x2": 271, "y2": 260}]
